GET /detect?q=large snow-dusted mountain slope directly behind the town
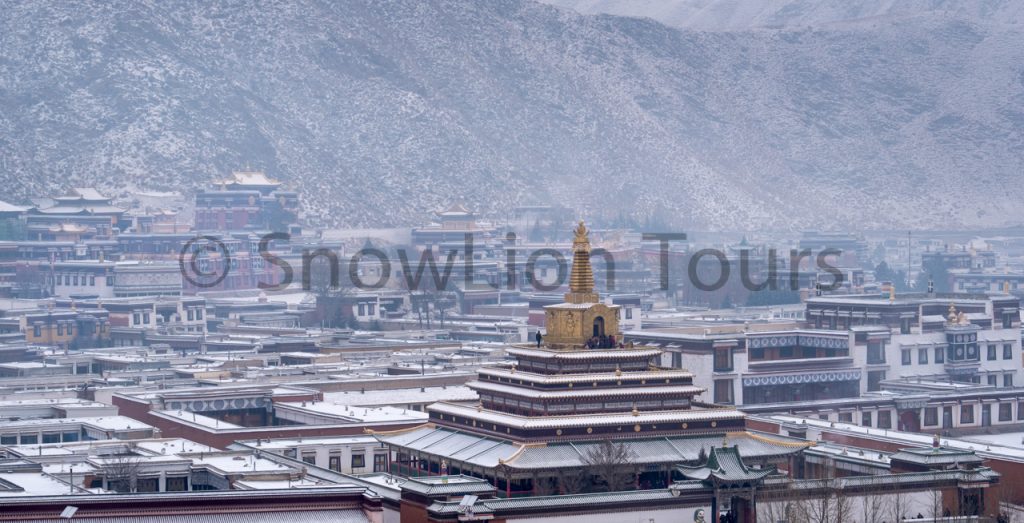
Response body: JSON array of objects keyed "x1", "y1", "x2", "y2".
[{"x1": 0, "y1": 0, "x2": 1024, "y2": 229}]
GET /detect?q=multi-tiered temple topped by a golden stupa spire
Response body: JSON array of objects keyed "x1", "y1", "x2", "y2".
[{"x1": 381, "y1": 222, "x2": 804, "y2": 494}]
